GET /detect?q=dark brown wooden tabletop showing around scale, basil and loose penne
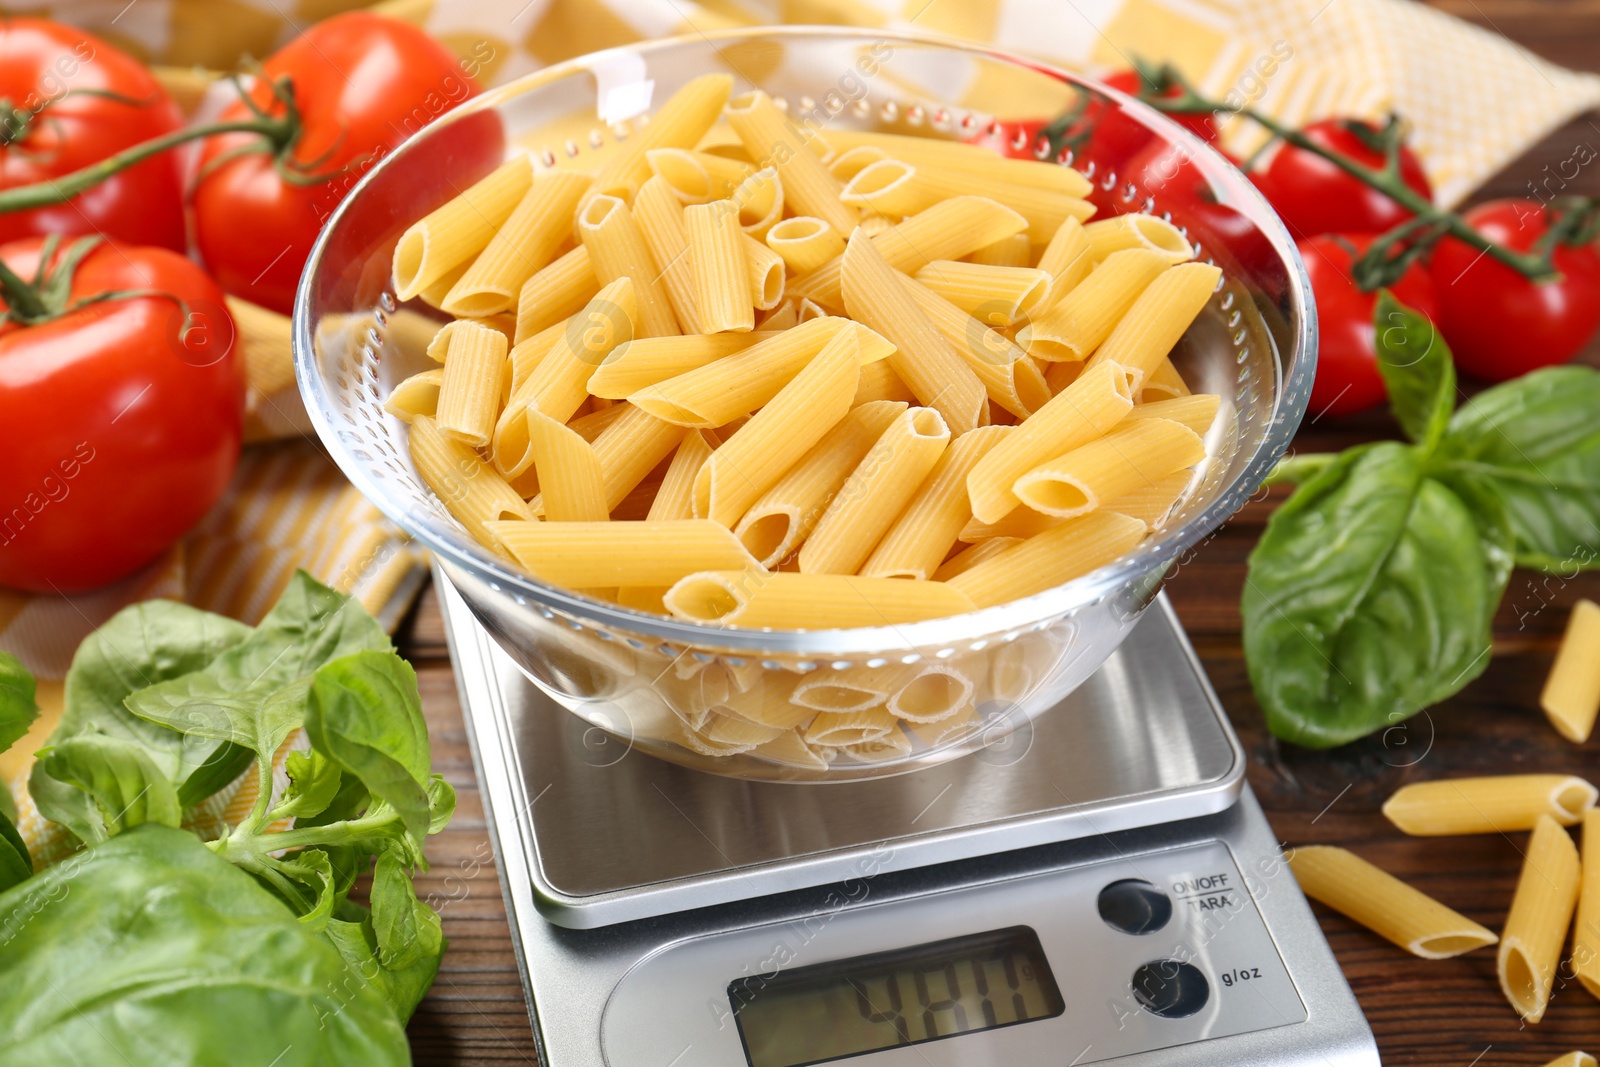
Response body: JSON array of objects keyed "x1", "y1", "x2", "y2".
[{"x1": 400, "y1": 0, "x2": 1600, "y2": 1067}]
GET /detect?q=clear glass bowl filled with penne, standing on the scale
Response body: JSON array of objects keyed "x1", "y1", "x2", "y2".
[{"x1": 296, "y1": 29, "x2": 1315, "y2": 781}]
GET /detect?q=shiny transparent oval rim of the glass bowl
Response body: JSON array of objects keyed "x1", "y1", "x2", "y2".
[{"x1": 293, "y1": 26, "x2": 1317, "y2": 662}]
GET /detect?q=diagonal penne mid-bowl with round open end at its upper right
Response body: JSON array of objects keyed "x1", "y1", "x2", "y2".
[{"x1": 800, "y1": 408, "x2": 950, "y2": 574}]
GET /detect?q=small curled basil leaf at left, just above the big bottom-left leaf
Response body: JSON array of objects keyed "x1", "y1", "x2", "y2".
[{"x1": 40, "y1": 734, "x2": 182, "y2": 840}]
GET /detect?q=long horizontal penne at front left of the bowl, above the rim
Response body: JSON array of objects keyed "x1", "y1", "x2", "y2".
[{"x1": 490, "y1": 518, "x2": 757, "y2": 589}]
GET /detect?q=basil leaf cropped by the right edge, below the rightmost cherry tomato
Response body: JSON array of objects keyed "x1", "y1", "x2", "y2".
[{"x1": 1438, "y1": 366, "x2": 1600, "y2": 573}]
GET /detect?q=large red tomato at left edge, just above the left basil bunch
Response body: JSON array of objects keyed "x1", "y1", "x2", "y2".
[{"x1": 0, "y1": 238, "x2": 245, "y2": 593}]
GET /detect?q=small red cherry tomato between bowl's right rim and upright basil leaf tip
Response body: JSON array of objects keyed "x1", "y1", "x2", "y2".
[{"x1": 1299, "y1": 234, "x2": 1438, "y2": 418}]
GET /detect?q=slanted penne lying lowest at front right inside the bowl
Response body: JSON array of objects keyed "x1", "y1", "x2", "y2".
[{"x1": 950, "y1": 515, "x2": 1146, "y2": 608}]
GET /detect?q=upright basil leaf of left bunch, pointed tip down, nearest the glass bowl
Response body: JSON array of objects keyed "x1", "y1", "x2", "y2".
[{"x1": 306, "y1": 651, "x2": 429, "y2": 843}]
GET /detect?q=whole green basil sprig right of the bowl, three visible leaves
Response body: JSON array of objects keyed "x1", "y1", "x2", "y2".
[{"x1": 1240, "y1": 291, "x2": 1600, "y2": 749}]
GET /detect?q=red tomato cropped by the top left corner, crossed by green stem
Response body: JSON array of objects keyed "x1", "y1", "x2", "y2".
[{"x1": 0, "y1": 18, "x2": 184, "y2": 251}]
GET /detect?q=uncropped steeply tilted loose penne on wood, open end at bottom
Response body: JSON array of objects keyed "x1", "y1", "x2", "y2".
[{"x1": 1494, "y1": 814, "x2": 1579, "y2": 1022}]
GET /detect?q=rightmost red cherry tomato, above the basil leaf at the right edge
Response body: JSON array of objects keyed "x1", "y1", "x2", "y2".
[{"x1": 1430, "y1": 200, "x2": 1600, "y2": 382}]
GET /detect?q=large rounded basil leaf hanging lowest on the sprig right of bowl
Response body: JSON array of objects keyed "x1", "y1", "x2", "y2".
[{"x1": 1240, "y1": 442, "x2": 1506, "y2": 749}]
